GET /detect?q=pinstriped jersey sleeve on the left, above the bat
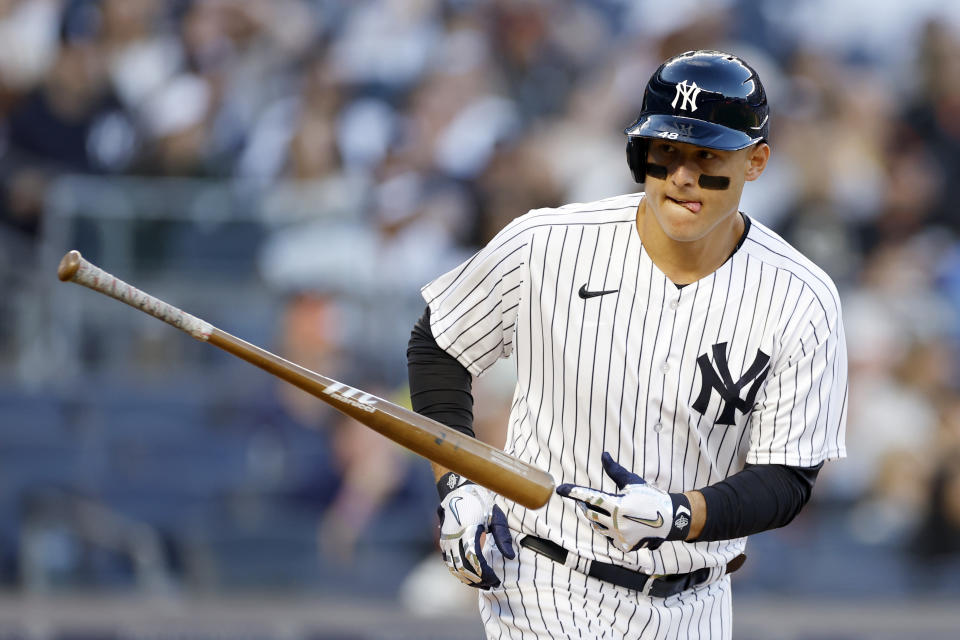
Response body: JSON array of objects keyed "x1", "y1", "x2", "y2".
[{"x1": 421, "y1": 217, "x2": 529, "y2": 376}]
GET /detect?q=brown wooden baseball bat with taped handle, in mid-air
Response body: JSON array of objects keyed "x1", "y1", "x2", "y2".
[{"x1": 57, "y1": 251, "x2": 554, "y2": 509}]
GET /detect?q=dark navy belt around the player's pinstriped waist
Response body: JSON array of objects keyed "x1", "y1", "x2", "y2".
[{"x1": 520, "y1": 536, "x2": 747, "y2": 598}]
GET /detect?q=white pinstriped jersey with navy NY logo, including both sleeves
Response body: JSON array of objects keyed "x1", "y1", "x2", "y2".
[{"x1": 423, "y1": 193, "x2": 847, "y2": 574}]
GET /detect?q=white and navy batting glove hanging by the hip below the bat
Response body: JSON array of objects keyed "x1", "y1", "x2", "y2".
[{"x1": 437, "y1": 473, "x2": 516, "y2": 590}]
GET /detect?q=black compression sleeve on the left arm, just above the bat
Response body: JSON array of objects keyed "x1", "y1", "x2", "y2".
[{"x1": 407, "y1": 306, "x2": 474, "y2": 436}]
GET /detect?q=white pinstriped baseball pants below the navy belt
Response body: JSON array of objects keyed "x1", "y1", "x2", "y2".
[{"x1": 479, "y1": 539, "x2": 733, "y2": 640}]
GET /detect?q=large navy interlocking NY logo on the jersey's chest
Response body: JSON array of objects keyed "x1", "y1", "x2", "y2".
[{"x1": 693, "y1": 342, "x2": 770, "y2": 424}]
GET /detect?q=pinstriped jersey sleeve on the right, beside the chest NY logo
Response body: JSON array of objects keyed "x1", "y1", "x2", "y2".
[{"x1": 747, "y1": 289, "x2": 847, "y2": 467}]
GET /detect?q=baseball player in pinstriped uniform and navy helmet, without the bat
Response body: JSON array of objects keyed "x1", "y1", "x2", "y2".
[{"x1": 408, "y1": 51, "x2": 847, "y2": 640}]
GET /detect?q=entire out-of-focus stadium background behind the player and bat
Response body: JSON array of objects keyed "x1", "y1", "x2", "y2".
[{"x1": 0, "y1": 0, "x2": 960, "y2": 640}]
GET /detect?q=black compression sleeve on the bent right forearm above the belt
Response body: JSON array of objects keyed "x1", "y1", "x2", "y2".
[{"x1": 697, "y1": 464, "x2": 823, "y2": 542}]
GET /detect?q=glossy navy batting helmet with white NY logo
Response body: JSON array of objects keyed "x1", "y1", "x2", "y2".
[{"x1": 624, "y1": 51, "x2": 769, "y2": 183}]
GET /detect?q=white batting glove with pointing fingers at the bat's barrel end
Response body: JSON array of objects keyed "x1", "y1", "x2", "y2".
[{"x1": 557, "y1": 452, "x2": 690, "y2": 551}]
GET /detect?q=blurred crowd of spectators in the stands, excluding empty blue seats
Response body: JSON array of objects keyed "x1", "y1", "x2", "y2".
[{"x1": 0, "y1": 0, "x2": 960, "y2": 596}]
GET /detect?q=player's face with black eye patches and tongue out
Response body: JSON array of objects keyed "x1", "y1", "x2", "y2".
[{"x1": 646, "y1": 140, "x2": 770, "y2": 242}]
